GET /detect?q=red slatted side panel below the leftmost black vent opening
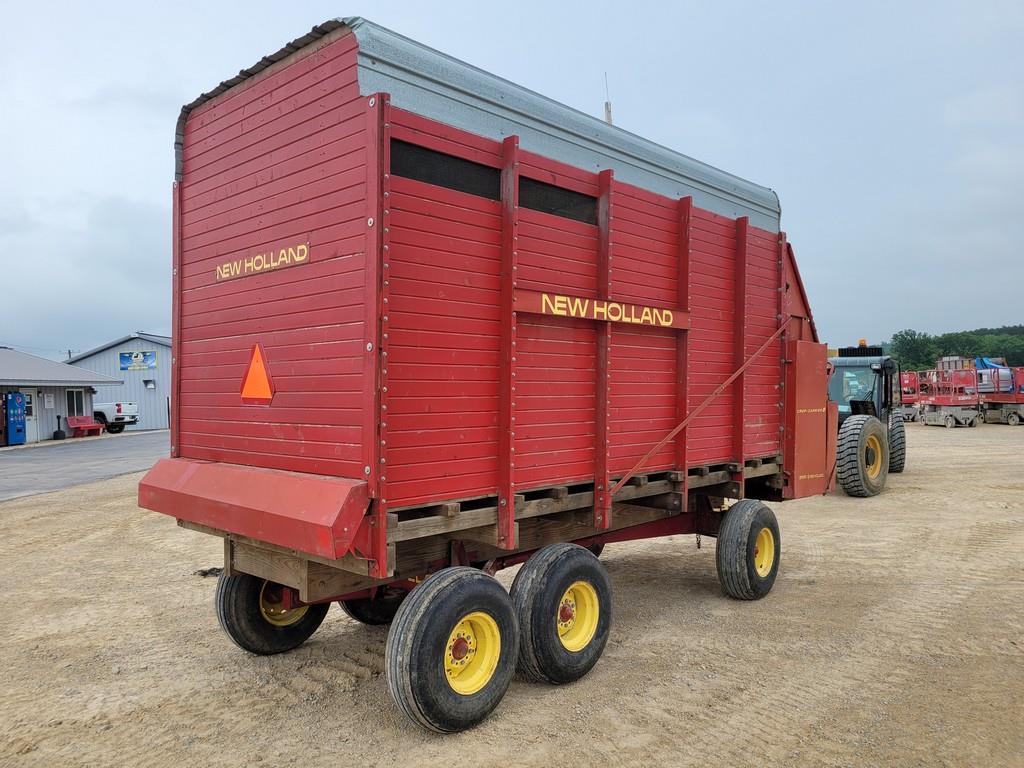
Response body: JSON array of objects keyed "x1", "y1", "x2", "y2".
[{"x1": 384, "y1": 176, "x2": 502, "y2": 508}]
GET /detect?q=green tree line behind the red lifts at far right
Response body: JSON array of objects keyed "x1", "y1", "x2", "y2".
[{"x1": 887, "y1": 326, "x2": 1024, "y2": 371}]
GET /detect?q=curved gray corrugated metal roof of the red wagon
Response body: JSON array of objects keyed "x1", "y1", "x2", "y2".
[{"x1": 175, "y1": 16, "x2": 781, "y2": 231}]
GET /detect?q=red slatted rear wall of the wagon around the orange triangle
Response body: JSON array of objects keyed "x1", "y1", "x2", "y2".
[{"x1": 177, "y1": 35, "x2": 367, "y2": 477}]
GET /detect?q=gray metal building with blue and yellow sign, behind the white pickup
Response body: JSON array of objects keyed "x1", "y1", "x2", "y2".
[{"x1": 68, "y1": 331, "x2": 171, "y2": 429}]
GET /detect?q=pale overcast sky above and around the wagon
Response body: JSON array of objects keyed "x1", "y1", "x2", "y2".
[{"x1": 0, "y1": 0, "x2": 1024, "y2": 357}]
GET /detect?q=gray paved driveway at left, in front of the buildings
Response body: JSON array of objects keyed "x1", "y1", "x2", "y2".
[{"x1": 0, "y1": 429, "x2": 171, "y2": 502}]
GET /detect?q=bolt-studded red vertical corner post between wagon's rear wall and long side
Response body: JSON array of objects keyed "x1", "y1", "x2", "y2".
[{"x1": 362, "y1": 93, "x2": 391, "y2": 578}]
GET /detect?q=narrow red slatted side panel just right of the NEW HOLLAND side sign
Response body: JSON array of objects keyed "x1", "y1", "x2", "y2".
[{"x1": 687, "y1": 208, "x2": 736, "y2": 465}]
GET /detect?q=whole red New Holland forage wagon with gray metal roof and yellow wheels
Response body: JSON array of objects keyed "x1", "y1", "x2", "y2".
[{"x1": 139, "y1": 18, "x2": 838, "y2": 731}]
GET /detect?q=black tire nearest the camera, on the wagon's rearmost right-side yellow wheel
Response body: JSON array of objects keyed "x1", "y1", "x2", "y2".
[{"x1": 385, "y1": 566, "x2": 519, "y2": 733}]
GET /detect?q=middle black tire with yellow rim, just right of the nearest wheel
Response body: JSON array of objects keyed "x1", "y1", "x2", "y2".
[{"x1": 511, "y1": 544, "x2": 611, "y2": 684}]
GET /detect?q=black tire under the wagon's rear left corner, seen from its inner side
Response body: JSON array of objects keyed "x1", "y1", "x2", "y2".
[{"x1": 214, "y1": 573, "x2": 330, "y2": 655}]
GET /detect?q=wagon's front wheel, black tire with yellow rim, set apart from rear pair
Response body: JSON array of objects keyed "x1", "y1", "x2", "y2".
[{"x1": 715, "y1": 499, "x2": 782, "y2": 600}]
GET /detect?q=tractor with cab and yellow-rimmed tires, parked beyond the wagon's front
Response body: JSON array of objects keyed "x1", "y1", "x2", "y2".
[{"x1": 828, "y1": 342, "x2": 906, "y2": 497}]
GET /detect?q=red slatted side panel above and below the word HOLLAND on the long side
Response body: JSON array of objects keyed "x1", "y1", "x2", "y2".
[{"x1": 610, "y1": 182, "x2": 679, "y2": 475}]
